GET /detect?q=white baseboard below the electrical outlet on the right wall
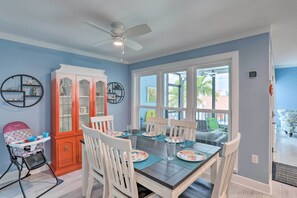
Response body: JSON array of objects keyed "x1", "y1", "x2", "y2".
[{"x1": 232, "y1": 174, "x2": 272, "y2": 195}]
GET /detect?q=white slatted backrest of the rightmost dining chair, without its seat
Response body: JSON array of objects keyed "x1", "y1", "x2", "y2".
[{"x1": 211, "y1": 133, "x2": 241, "y2": 198}]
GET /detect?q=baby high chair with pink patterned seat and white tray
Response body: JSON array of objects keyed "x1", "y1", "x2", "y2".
[{"x1": 0, "y1": 121, "x2": 63, "y2": 197}]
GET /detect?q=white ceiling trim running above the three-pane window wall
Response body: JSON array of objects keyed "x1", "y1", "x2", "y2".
[{"x1": 130, "y1": 26, "x2": 271, "y2": 64}]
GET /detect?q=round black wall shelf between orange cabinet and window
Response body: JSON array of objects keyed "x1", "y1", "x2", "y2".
[{"x1": 107, "y1": 82, "x2": 125, "y2": 104}]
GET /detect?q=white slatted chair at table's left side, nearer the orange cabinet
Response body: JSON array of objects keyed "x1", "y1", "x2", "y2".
[{"x1": 82, "y1": 125, "x2": 108, "y2": 198}]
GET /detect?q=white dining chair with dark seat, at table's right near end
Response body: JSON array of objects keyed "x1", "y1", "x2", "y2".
[{"x1": 179, "y1": 133, "x2": 241, "y2": 198}]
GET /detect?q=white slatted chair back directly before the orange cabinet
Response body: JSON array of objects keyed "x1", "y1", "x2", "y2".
[{"x1": 90, "y1": 115, "x2": 114, "y2": 133}]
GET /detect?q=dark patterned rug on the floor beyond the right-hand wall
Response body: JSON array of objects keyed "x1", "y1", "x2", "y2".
[{"x1": 272, "y1": 162, "x2": 297, "y2": 187}]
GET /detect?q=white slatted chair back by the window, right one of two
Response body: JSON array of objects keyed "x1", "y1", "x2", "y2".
[{"x1": 169, "y1": 120, "x2": 197, "y2": 141}]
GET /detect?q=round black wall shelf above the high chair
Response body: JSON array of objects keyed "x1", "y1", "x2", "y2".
[{"x1": 0, "y1": 74, "x2": 44, "y2": 108}]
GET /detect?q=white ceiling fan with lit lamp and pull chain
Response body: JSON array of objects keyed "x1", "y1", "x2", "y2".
[{"x1": 84, "y1": 21, "x2": 152, "y2": 53}]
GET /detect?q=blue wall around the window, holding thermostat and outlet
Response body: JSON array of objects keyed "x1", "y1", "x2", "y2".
[{"x1": 129, "y1": 33, "x2": 270, "y2": 184}]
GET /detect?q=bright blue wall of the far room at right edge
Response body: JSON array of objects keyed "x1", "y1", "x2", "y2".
[{"x1": 275, "y1": 67, "x2": 297, "y2": 127}]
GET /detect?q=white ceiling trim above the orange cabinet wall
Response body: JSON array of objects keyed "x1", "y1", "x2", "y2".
[{"x1": 0, "y1": 31, "x2": 129, "y2": 64}]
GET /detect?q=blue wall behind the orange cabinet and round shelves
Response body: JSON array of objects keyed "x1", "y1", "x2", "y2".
[{"x1": 0, "y1": 39, "x2": 130, "y2": 174}]
